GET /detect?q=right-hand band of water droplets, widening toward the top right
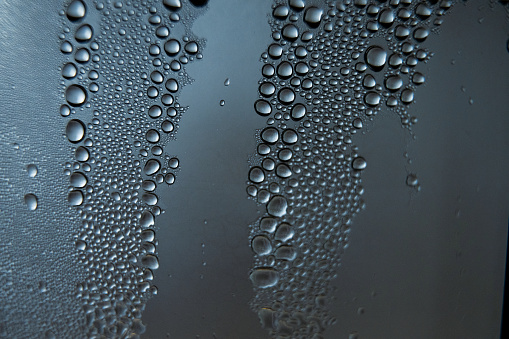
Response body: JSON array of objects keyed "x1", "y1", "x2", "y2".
[{"x1": 247, "y1": 0, "x2": 453, "y2": 338}]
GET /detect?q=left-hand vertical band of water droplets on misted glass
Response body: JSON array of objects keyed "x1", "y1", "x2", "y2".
[{"x1": 57, "y1": 0, "x2": 206, "y2": 337}]
